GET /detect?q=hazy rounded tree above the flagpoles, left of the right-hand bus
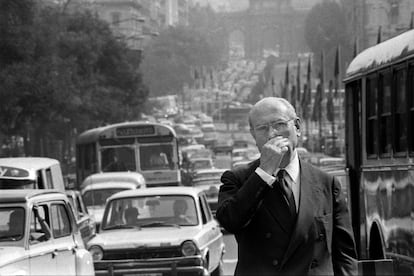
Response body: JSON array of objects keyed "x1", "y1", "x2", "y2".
[{"x1": 305, "y1": 0, "x2": 352, "y2": 82}]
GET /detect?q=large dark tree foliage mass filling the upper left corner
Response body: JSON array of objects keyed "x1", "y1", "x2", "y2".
[{"x1": 0, "y1": 0, "x2": 148, "y2": 153}]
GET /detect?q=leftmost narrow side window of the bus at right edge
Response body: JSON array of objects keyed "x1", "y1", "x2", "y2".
[{"x1": 366, "y1": 74, "x2": 378, "y2": 157}]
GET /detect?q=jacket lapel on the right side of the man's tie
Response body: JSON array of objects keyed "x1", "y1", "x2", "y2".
[{"x1": 282, "y1": 162, "x2": 317, "y2": 266}]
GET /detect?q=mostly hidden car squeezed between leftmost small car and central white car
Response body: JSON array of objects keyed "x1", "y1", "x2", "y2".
[{"x1": 65, "y1": 190, "x2": 96, "y2": 243}]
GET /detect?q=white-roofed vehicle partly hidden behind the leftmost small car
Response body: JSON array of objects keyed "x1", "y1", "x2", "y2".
[{"x1": 0, "y1": 157, "x2": 65, "y2": 192}]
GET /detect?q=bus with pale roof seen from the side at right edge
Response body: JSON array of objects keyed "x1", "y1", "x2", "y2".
[{"x1": 344, "y1": 30, "x2": 414, "y2": 275}]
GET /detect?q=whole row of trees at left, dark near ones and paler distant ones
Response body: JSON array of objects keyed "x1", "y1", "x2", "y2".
[{"x1": 0, "y1": 0, "x2": 220, "y2": 162}]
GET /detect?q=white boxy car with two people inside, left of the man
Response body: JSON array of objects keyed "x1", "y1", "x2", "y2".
[{"x1": 87, "y1": 186, "x2": 224, "y2": 275}]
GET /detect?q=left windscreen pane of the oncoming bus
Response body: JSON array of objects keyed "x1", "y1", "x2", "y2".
[{"x1": 101, "y1": 147, "x2": 137, "y2": 172}]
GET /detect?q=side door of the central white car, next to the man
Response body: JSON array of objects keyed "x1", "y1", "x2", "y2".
[{"x1": 199, "y1": 193, "x2": 223, "y2": 270}]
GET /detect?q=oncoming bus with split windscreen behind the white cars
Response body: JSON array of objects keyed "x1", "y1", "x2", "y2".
[{"x1": 76, "y1": 121, "x2": 181, "y2": 189}]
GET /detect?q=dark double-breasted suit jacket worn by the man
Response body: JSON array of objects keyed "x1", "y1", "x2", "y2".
[{"x1": 216, "y1": 160, "x2": 357, "y2": 275}]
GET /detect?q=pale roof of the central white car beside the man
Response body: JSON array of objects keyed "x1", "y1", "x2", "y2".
[{"x1": 108, "y1": 186, "x2": 200, "y2": 200}]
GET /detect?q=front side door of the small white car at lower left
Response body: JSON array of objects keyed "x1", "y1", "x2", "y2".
[{"x1": 28, "y1": 204, "x2": 56, "y2": 275}]
